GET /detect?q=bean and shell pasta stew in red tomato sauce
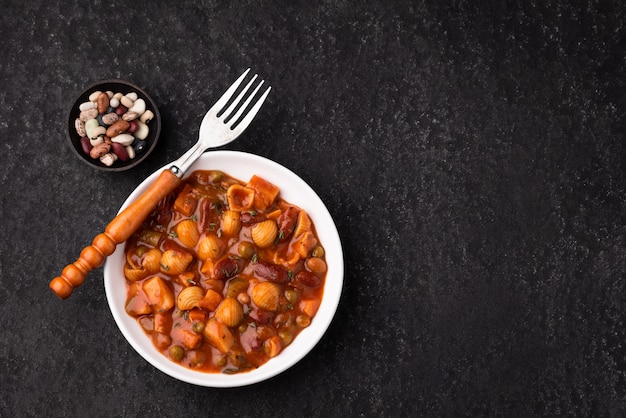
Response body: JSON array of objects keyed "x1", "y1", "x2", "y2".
[{"x1": 124, "y1": 170, "x2": 327, "y2": 373}]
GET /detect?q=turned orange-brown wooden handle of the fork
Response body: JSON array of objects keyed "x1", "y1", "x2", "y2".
[{"x1": 50, "y1": 169, "x2": 180, "y2": 299}]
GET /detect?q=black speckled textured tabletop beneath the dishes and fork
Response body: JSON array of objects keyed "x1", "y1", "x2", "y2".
[{"x1": 0, "y1": 0, "x2": 626, "y2": 417}]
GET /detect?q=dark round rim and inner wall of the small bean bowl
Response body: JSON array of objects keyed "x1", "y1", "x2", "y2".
[{"x1": 66, "y1": 78, "x2": 161, "y2": 172}]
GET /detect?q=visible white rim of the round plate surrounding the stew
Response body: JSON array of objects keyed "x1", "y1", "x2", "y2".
[{"x1": 104, "y1": 151, "x2": 344, "y2": 387}]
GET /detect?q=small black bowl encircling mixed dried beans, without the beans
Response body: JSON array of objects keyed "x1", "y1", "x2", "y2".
[{"x1": 67, "y1": 80, "x2": 161, "y2": 171}]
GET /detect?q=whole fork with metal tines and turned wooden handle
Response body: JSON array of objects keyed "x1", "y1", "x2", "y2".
[{"x1": 50, "y1": 69, "x2": 271, "y2": 299}]
